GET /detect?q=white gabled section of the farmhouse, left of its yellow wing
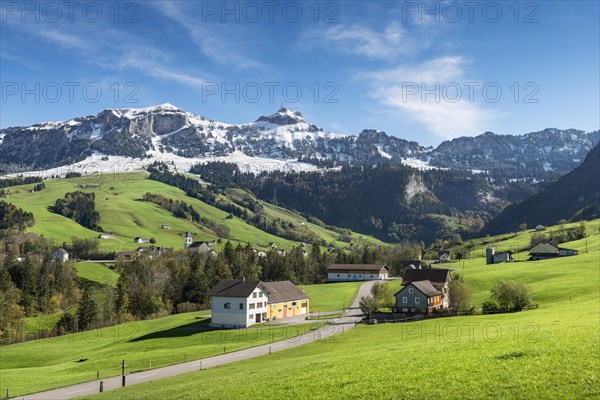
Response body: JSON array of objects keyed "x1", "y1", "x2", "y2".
[{"x1": 208, "y1": 279, "x2": 268, "y2": 328}]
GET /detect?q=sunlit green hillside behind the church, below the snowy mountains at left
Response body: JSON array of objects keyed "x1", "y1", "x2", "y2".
[{"x1": 3, "y1": 173, "x2": 381, "y2": 251}]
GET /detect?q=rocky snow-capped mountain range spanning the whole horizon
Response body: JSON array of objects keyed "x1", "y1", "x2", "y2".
[{"x1": 0, "y1": 104, "x2": 600, "y2": 179}]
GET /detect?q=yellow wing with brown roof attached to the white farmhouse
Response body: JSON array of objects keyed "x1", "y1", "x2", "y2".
[{"x1": 262, "y1": 281, "x2": 310, "y2": 320}]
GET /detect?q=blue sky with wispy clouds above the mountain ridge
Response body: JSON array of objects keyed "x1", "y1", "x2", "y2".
[{"x1": 0, "y1": 1, "x2": 600, "y2": 145}]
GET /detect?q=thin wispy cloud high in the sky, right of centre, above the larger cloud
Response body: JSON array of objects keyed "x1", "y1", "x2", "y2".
[{"x1": 301, "y1": 22, "x2": 422, "y2": 59}]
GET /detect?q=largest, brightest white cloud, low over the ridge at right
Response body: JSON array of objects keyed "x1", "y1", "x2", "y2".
[{"x1": 359, "y1": 56, "x2": 495, "y2": 139}]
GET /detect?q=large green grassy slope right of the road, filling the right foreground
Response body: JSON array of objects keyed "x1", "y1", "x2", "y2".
[{"x1": 83, "y1": 220, "x2": 600, "y2": 399}]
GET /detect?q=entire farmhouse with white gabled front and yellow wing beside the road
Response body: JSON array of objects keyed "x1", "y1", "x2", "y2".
[{"x1": 208, "y1": 279, "x2": 310, "y2": 328}]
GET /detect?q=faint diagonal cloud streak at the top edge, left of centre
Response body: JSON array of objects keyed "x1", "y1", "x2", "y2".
[{"x1": 157, "y1": 1, "x2": 263, "y2": 69}]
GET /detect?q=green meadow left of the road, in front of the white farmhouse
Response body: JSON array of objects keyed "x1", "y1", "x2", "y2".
[{"x1": 0, "y1": 311, "x2": 322, "y2": 396}]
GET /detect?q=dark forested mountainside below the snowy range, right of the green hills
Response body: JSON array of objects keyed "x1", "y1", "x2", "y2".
[{"x1": 191, "y1": 162, "x2": 537, "y2": 243}]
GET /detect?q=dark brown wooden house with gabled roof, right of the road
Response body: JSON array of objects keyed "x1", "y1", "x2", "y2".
[{"x1": 394, "y1": 281, "x2": 445, "y2": 314}]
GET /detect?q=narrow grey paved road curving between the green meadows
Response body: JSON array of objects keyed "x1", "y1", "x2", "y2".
[{"x1": 19, "y1": 281, "x2": 377, "y2": 400}]
